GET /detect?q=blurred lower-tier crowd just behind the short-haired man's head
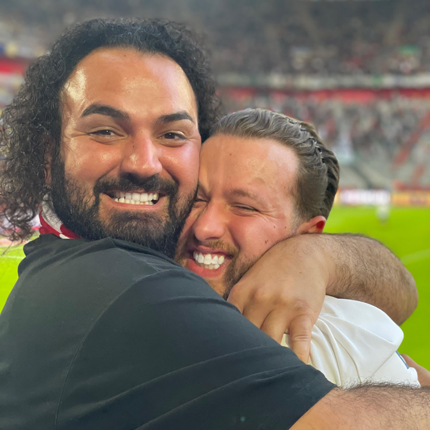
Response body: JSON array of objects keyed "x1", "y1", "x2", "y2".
[{"x1": 222, "y1": 90, "x2": 430, "y2": 161}]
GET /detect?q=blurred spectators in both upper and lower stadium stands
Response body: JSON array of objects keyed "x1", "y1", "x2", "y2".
[{"x1": 0, "y1": 0, "x2": 430, "y2": 183}]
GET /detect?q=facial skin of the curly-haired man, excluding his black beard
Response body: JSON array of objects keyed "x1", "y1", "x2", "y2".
[{"x1": 47, "y1": 48, "x2": 201, "y2": 232}]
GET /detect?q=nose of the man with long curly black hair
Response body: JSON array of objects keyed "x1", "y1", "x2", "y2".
[{"x1": 121, "y1": 137, "x2": 163, "y2": 178}]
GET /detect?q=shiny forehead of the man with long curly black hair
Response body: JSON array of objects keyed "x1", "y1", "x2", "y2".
[{"x1": 62, "y1": 48, "x2": 197, "y2": 115}]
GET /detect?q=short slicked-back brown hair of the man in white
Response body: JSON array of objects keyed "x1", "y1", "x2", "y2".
[{"x1": 211, "y1": 109, "x2": 339, "y2": 220}]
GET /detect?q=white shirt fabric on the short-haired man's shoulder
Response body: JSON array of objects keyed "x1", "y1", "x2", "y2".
[{"x1": 282, "y1": 296, "x2": 419, "y2": 386}]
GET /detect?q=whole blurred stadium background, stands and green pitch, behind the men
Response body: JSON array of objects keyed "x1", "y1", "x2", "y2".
[{"x1": 0, "y1": 0, "x2": 430, "y2": 368}]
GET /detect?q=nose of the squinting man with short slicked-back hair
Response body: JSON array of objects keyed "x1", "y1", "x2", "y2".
[{"x1": 193, "y1": 203, "x2": 227, "y2": 242}]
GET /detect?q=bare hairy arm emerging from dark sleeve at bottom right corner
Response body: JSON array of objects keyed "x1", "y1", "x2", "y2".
[{"x1": 291, "y1": 385, "x2": 430, "y2": 430}]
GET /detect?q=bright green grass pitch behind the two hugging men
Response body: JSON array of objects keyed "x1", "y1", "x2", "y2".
[{"x1": 0, "y1": 207, "x2": 430, "y2": 369}]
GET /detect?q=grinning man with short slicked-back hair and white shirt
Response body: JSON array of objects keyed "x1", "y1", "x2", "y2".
[{"x1": 177, "y1": 109, "x2": 419, "y2": 386}]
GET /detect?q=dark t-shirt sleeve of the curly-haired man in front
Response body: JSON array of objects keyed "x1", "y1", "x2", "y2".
[{"x1": 57, "y1": 269, "x2": 333, "y2": 430}]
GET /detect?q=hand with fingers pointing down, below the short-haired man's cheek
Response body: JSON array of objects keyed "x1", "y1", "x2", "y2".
[{"x1": 228, "y1": 235, "x2": 330, "y2": 363}]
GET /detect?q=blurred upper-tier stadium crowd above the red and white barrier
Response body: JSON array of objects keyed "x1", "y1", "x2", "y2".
[{"x1": 0, "y1": 0, "x2": 430, "y2": 75}]
